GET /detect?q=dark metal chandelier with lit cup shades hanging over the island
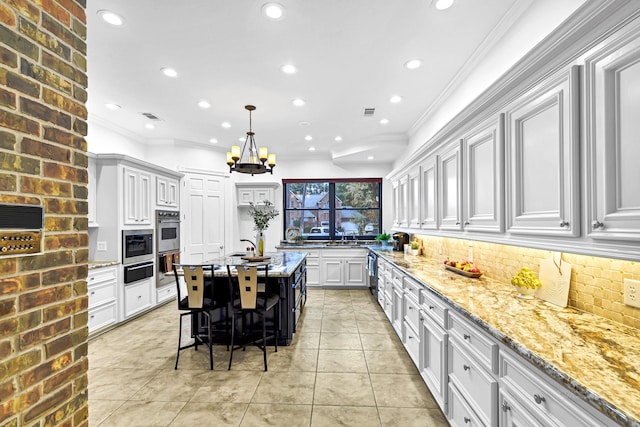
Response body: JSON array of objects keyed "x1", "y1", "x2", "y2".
[{"x1": 227, "y1": 105, "x2": 276, "y2": 175}]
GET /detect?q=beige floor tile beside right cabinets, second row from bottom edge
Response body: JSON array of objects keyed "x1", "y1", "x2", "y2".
[{"x1": 370, "y1": 374, "x2": 438, "y2": 408}]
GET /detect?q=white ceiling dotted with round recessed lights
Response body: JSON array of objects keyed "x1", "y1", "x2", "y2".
[{"x1": 87, "y1": 0, "x2": 524, "y2": 163}]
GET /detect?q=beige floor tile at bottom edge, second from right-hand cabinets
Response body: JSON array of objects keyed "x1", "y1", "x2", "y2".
[{"x1": 311, "y1": 405, "x2": 380, "y2": 427}]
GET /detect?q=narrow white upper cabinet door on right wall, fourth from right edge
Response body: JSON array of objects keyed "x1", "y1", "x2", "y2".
[{"x1": 438, "y1": 141, "x2": 462, "y2": 230}]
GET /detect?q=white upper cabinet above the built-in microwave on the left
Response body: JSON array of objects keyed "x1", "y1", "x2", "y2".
[{"x1": 122, "y1": 166, "x2": 151, "y2": 225}]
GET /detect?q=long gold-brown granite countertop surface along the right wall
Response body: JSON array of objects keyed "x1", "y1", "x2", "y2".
[{"x1": 372, "y1": 248, "x2": 640, "y2": 426}]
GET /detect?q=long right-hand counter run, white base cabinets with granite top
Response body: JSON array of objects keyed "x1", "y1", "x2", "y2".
[{"x1": 376, "y1": 250, "x2": 640, "y2": 426}]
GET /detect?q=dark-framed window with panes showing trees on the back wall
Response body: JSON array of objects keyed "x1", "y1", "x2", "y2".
[{"x1": 283, "y1": 178, "x2": 382, "y2": 240}]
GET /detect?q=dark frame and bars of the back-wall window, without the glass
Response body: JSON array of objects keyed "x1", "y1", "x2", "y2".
[{"x1": 282, "y1": 178, "x2": 382, "y2": 240}]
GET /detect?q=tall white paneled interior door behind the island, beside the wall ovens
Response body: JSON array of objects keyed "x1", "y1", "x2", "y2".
[{"x1": 180, "y1": 172, "x2": 225, "y2": 263}]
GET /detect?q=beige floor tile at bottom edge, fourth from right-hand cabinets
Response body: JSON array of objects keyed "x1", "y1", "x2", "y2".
[{"x1": 170, "y1": 402, "x2": 249, "y2": 427}]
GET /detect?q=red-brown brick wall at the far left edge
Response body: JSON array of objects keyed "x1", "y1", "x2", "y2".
[{"x1": 0, "y1": 0, "x2": 88, "y2": 426}]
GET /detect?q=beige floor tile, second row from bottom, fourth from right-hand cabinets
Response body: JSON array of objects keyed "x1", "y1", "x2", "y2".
[{"x1": 191, "y1": 370, "x2": 262, "y2": 403}]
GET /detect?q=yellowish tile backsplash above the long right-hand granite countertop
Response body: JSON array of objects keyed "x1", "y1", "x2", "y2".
[{"x1": 415, "y1": 235, "x2": 640, "y2": 329}]
